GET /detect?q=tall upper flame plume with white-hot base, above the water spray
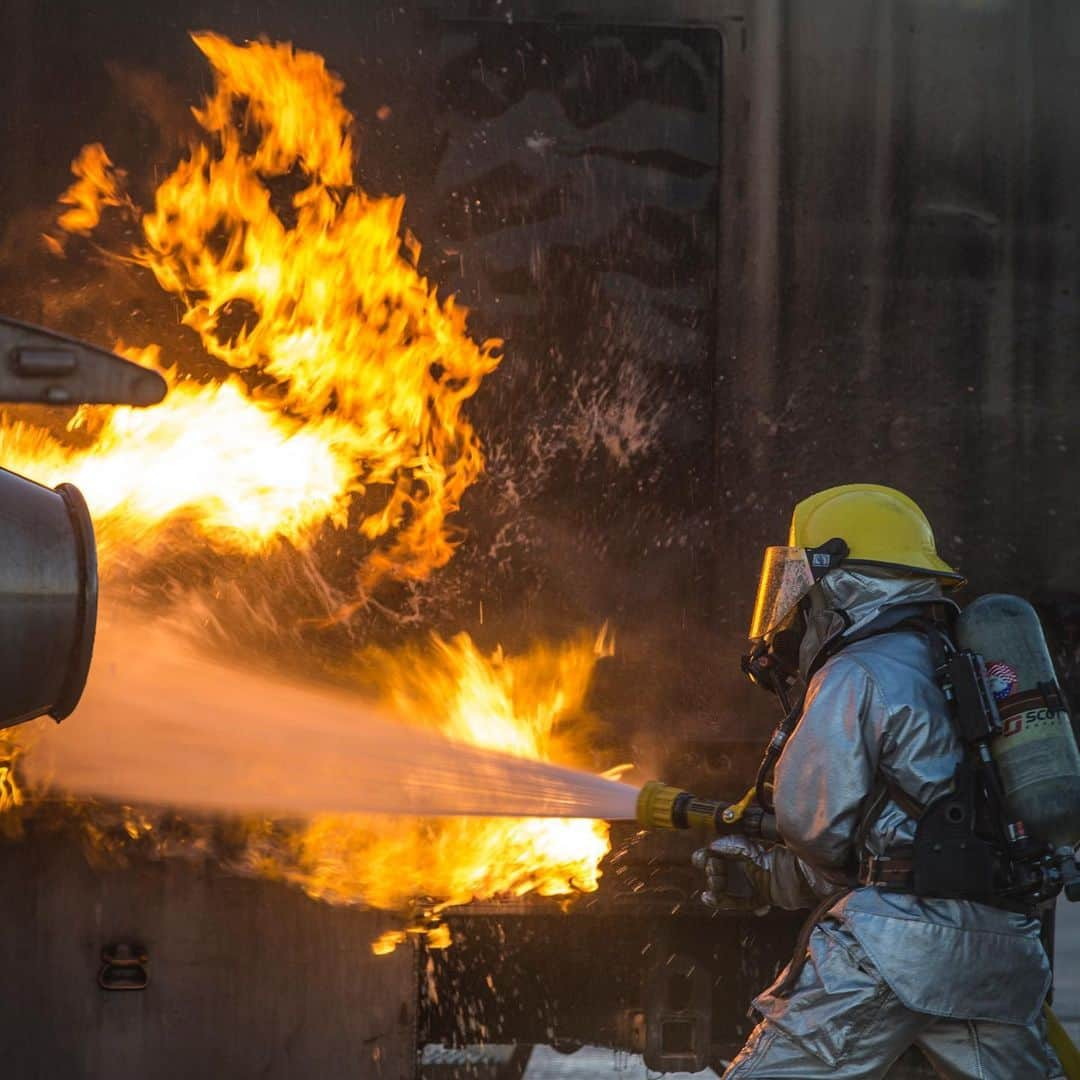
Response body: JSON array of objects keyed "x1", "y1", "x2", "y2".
[{"x1": 16, "y1": 33, "x2": 499, "y2": 586}]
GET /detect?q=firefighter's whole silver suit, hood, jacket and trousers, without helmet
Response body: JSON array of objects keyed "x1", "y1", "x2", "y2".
[{"x1": 724, "y1": 567, "x2": 1063, "y2": 1080}]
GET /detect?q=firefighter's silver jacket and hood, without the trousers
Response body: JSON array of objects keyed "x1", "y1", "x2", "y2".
[{"x1": 765, "y1": 569, "x2": 1050, "y2": 1024}]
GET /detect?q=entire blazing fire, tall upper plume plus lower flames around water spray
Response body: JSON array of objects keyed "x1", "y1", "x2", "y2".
[{"x1": 0, "y1": 25, "x2": 626, "y2": 948}]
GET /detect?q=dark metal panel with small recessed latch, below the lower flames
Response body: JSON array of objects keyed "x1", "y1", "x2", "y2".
[{"x1": 0, "y1": 834, "x2": 416, "y2": 1080}]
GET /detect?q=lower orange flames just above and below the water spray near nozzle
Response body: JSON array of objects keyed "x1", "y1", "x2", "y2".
[{"x1": 249, "y1": 633, "x2": 610, "y2": 951}]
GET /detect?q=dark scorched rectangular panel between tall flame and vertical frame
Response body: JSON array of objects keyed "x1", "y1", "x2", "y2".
[{"x1": 430, "y1": 5, "x2": 727, "y2": 769}]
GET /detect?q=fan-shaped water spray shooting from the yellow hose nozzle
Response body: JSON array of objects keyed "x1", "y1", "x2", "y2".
[{"x1": 24, "y1": 611, "x2": 637, "y2": 820}]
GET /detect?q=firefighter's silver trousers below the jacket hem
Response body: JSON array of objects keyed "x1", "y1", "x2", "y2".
[{"x1": 724, "y1": 921, "x2": 1065, "y2": 1080}]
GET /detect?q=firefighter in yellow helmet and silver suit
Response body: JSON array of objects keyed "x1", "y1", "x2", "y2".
[{"x1": 694, "y1": 484, "x2": 1064, "y2": 1080}]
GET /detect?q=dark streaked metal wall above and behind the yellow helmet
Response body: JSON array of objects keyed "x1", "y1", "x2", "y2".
[{"x1": 727, "y1": 0, "x2": 1080, "y2": 708}]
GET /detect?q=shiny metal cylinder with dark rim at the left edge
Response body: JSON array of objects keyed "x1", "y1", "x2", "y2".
[{"x1": 0, "y1": 469, "x2": 97, "y2": 728}]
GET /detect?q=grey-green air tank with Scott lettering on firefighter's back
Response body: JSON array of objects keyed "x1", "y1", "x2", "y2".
[{"x1": 956, "y1": 593, "x2": 1080, "y2": 850}]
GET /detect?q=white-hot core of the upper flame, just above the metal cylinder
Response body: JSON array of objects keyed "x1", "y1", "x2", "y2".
[{"x1": 0, "y1": 348, "x2": 354, "y2": 561}]
